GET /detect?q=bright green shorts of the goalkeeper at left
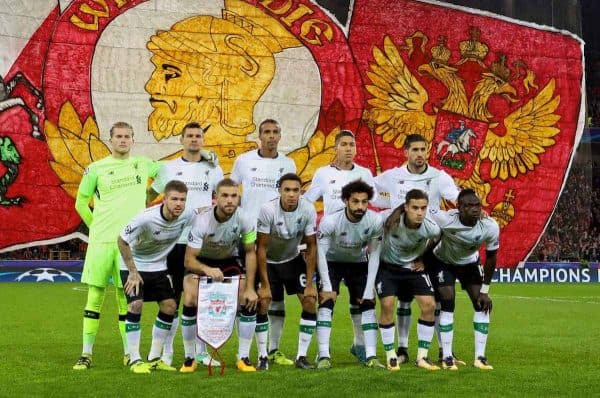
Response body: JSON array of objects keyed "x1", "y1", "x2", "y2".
[{"x1": 81, "y1": 242, "x2": 123, "y2": 287}]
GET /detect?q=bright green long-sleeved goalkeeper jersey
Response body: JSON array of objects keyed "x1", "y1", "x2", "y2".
[{"x1": 75, "y1": 156, "x2": 160, "y2": 243}]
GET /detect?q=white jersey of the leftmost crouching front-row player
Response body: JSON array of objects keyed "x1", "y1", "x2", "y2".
[{"x1": 120, "y1": 204, "x2": 194, "y2": 272}]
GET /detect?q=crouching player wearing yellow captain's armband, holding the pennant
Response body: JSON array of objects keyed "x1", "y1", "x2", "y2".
[{"x1": 180, "y1": 178, "x2": 258, "y2": 373}]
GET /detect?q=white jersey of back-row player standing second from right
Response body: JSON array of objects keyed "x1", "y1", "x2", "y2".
[{"x1": 304, "y1": 163, "x2": 377, "y2": 214}]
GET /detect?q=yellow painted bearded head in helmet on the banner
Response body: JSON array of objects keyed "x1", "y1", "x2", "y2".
[{"x1": 146, "y1": 16, "x2": 275, "y2": 145}]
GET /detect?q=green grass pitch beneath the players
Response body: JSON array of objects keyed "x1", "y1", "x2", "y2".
[{"x1": 0, "y1": 283, "x2": 600, "y2": 398}]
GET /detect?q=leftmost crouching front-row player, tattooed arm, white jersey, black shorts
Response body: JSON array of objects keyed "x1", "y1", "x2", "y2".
[{"x1": 117, "y1": 181, "x2": 193, "y2": 373}]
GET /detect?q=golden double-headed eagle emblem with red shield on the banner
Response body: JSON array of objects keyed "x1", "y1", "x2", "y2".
[{"x1": 363, "y1": 27, "x2": 560, "y2": 216}]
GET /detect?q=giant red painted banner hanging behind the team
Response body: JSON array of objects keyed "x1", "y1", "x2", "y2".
[{"x1": 0, "y1": 0, "x2": 583, "y2": 266}]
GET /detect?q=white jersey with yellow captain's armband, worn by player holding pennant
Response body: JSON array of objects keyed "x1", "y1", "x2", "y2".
[{"x1": 188, "y1": 206, "x2": 256, "y2": 260}]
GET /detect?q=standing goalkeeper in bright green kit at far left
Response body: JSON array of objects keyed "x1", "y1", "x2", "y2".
[{"x1": 73, "y1": 122, "x2": 160, "y2": 370}]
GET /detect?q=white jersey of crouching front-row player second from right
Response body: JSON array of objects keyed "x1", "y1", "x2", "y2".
[{"x1": 381, "y1": 210, "x2": 441, "y2": 268}]
